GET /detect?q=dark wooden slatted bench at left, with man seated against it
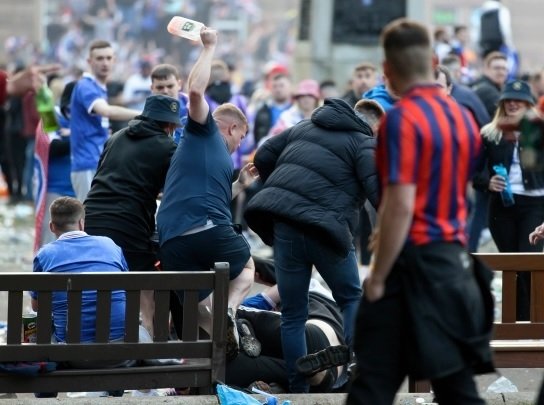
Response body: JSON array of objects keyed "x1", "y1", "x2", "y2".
[{"x1": 0, "y1": 263, "x2": 228, "y2": 393}]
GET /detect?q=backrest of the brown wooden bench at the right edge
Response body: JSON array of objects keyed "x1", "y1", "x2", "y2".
[{"x1": 474, "y1": 253, "x2": 544, "y2": 340}]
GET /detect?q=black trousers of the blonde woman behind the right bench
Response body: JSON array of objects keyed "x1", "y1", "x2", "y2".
[{"x1": 489, "y1": 193, "x2": 544, "y2": 321}]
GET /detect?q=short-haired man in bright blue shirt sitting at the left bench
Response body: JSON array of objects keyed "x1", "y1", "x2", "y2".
[{"x1": 30, "y1": 197, "x2": 128, "y2": 342}]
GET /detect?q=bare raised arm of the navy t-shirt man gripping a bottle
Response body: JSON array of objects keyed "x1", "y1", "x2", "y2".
[{"x1": 187, "y1": 27, "x2": 217, "y2": 124}]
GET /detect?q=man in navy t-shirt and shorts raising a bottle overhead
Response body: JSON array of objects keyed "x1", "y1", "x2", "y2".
[{"x1": 157, "y1": 28, "x2": 257, "y2": 354}]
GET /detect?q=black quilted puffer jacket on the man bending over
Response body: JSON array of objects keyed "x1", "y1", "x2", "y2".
[{"x1": 245, "y1": 99, "x2": 378, "y2": 255}]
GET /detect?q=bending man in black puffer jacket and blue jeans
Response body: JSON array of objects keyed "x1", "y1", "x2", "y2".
[{"x1": 245, "y1": 99, "x2": 378, "y2": 392}]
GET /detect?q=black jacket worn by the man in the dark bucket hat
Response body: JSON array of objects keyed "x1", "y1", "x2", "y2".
[{"x1": 85, "y1": 116, "x2": 176, "y2": 242}]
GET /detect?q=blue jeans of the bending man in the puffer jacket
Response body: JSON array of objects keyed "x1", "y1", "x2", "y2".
[{"x1": 274, "y1": 222, "x2": 361, "y2": 392}]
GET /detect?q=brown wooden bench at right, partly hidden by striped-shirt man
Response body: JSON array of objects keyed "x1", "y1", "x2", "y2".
[{"x1": 408, "y1": 253, "x2": 544, "y2": 392}]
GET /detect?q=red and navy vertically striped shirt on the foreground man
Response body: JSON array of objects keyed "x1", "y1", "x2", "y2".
[{"x1": 377, "y1": 85, "x2": 481, "y2": 245}]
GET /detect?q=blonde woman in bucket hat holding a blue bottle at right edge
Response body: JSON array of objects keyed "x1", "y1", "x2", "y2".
[{"x1": 474, "y1": 80, "x2": 544, "y2": 321}]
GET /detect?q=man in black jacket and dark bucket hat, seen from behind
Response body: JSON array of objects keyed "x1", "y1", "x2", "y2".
[{"x1": 85, "y1": 95, "x2": 180, "y2": 335}]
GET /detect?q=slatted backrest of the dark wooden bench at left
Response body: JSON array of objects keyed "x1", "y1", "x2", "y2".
[{"x1": 0, "y1": 263, "x2": 228, "y2": 370}]
